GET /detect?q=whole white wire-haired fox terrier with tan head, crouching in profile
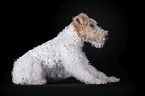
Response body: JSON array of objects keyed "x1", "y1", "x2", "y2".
[{"x1": 12, "y1": 13, "x2": 120, "y2": 85}]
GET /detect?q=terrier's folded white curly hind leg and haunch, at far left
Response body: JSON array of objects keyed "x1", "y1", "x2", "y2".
[{"x1": 12, "y1": 55, "x2": 46, "y2": 85}]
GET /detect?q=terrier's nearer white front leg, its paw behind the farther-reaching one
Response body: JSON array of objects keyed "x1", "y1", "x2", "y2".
[{"x1": 62, "y1": 50, "x2": 104, "y2": 84}]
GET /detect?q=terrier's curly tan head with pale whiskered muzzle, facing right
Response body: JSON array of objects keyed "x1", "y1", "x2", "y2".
[{"x1": 72, "y1": 13, "x2": 108, "y2": 48}]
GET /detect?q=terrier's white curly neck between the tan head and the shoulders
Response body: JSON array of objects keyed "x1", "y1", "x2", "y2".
[{"x1": 57, "y1": 23, "x2": 84, "y2": 47}]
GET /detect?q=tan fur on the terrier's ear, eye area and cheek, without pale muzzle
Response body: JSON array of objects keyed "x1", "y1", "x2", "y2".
[{"x1": 72, "y1": 13, "x2": 99, "y2": 41}]
